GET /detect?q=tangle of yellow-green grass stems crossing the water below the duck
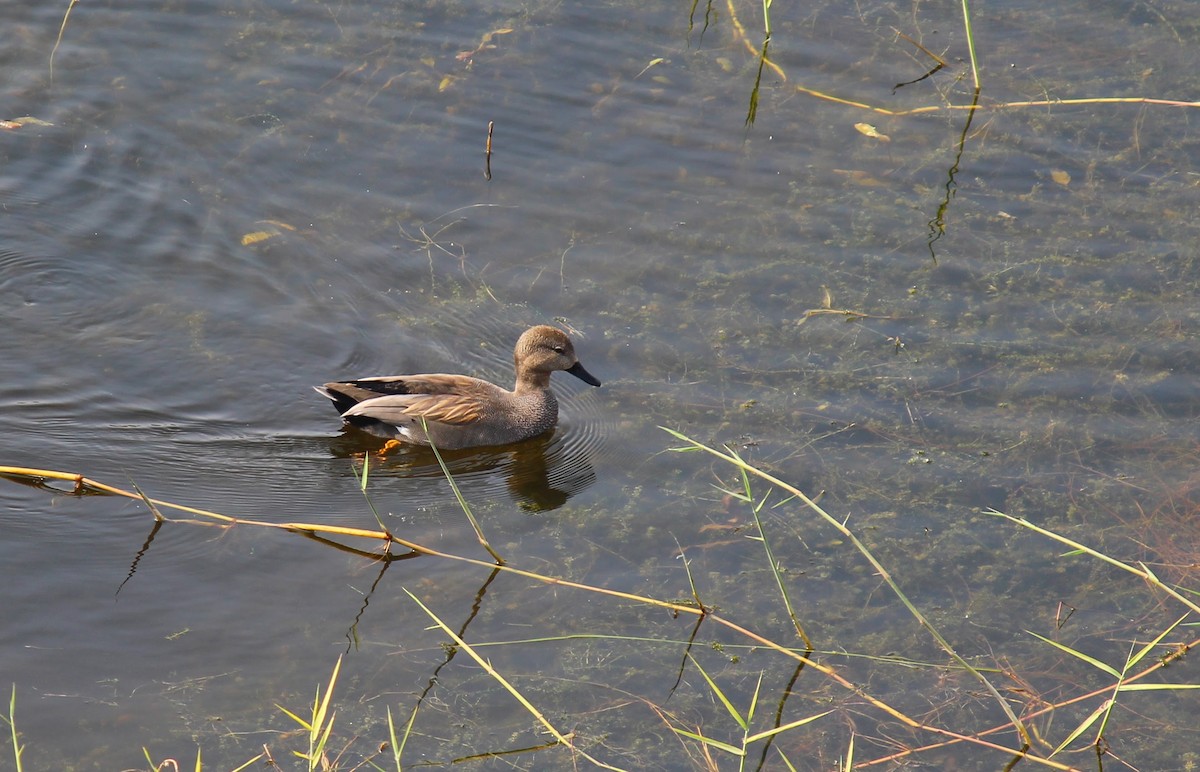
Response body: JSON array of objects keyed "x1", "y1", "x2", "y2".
[{"x1": 0, "y1": 427, "x2": 1200, "y2": 772}]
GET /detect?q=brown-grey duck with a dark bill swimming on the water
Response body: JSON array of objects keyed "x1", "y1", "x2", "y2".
[{"x1": 313, "y1": 324, "x2": 600, "y2": 449}]
